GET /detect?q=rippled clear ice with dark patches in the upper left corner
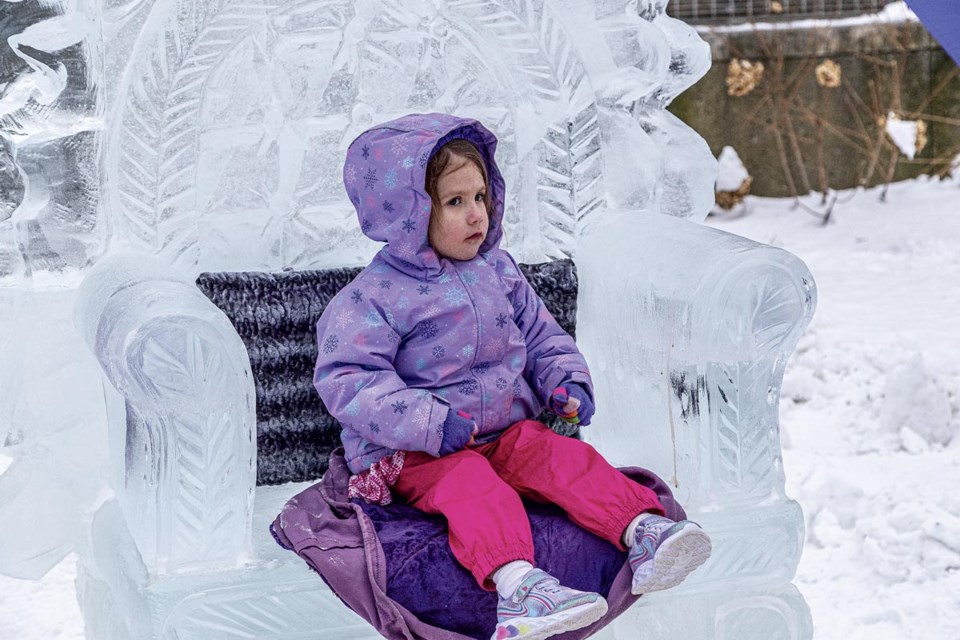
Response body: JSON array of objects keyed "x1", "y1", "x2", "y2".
[{"x1": 0, "y1": 0, "x2": 104, "y2": 281}]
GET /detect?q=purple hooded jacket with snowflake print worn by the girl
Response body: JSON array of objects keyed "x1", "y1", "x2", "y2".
[{"x1": 314, "y1": 114, "x2": 593, "y2": 473}]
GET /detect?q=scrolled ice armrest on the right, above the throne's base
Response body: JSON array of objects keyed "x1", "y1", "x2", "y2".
[{"x1": 576, "y1": 211, "x2": 816, "y2": 512}]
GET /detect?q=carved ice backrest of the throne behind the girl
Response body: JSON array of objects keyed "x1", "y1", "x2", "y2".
[{"x1": 103, "y1": 0, "x2": 712, "y2": 271}]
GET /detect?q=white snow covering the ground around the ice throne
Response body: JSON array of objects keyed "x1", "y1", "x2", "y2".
[{"x1": 0, "y1": 172, "x2": 960, "y2": 640}]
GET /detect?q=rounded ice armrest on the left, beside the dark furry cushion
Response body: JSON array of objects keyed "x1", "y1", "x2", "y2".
[{"x1": 76, "y1": 255, "x2": 256, "y2": 575}]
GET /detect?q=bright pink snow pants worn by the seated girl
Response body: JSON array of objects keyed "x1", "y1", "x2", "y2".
[{"x1": 392, "y1": 420, "x2": 664, "y2": 591}]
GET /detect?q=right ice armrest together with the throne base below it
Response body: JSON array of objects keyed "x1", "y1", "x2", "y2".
[{"x1": 577, "y1": 210, "x2": 816, "y2": 638}]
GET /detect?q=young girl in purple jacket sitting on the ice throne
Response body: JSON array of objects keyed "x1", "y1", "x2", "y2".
[{"x1": 314, "y1": 114, "x2": 711, "y2": 640}]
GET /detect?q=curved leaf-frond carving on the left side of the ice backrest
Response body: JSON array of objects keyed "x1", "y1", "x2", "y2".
[{"x1": 114, "y1": 1, "x2": 273, "y2": 267}]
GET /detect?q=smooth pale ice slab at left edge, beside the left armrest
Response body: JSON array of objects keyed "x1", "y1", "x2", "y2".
[{"x1": 0, "y1": 286, "x2": 107, "y2": 578}]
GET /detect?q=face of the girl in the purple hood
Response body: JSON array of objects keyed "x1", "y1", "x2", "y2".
[{"x1": 427, "y1": 156, "x2": 490, "y2": 260}]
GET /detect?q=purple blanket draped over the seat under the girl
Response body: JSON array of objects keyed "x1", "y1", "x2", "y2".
[{"x1": 270, "y1": 449, "x2": 684, "y2": 640}]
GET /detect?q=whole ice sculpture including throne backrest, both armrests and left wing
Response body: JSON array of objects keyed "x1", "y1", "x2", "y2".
[{"x1": 0, "y1": 0, "x2": 814, "y2": 640}]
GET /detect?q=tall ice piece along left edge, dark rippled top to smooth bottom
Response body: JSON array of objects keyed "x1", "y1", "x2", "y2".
[{"x1": 0, "y1": 2, "x2": 105, "y2": 577}]
